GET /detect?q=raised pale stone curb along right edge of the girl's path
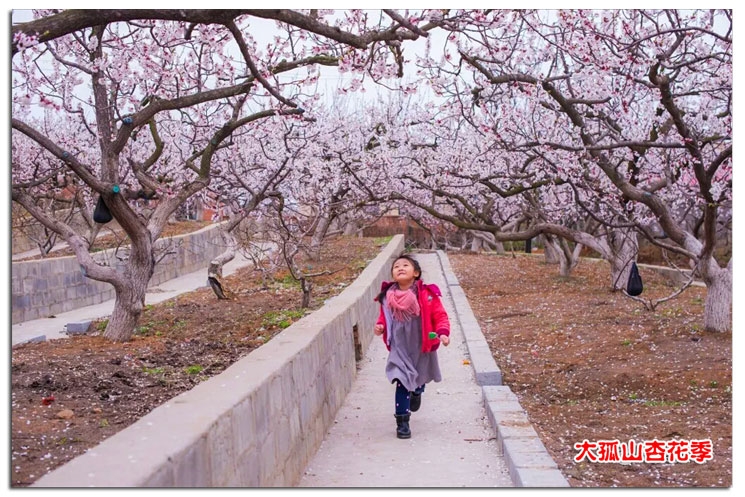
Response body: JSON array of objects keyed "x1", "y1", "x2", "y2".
[{"x1": 437, "y1": 250, "x2": 571, "y2": 488}]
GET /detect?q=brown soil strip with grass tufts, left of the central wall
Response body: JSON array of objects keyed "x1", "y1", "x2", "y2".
[{"x1": 10, "y1": 237, "x2": 387, "y2": 487}]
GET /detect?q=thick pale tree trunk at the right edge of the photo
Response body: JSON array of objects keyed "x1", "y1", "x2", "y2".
[{"x1": 701, "y1": 257, "x2": 732, "y2": 332}]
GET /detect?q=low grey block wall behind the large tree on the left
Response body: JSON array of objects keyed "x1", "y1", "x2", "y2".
[{"x1": 11, "y1": 225, "x2": 225, "y2": 324}]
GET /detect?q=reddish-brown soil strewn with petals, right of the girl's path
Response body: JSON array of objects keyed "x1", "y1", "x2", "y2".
[{"x1": 449, "y1": 254, "x2": 732, "y2": 487}]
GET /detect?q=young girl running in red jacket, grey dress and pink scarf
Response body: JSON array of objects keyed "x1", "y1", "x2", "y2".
[{"x1": 374, "y1": 255, "x2": 450, "y2": 438}]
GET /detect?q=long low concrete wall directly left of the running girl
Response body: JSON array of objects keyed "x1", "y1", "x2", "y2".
[{"x1": 34, "y1": 235, "x2": 404, "y2": 487}]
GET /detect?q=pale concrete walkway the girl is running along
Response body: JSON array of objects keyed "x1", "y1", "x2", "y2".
[{"x1": 299, "y1": 254, "x2": 513, "y2": 488}]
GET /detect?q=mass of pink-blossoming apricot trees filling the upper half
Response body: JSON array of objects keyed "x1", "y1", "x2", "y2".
[{"x1": 11, "y1": 9, "x2": 732, "y2": 339}]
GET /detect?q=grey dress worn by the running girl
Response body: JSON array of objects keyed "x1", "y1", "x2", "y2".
[{"x1": 383, "y1": 286, "x2": 442, "y2": 392}]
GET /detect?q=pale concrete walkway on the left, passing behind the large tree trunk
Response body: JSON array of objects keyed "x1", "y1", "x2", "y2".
[{"x1": 11, "y1": 253, "x2": 251, "y2": 345}]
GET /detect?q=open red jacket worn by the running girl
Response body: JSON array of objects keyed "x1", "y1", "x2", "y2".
[{"x1": 375, "y1": 280, "x2": 450, "y2": 352}]
